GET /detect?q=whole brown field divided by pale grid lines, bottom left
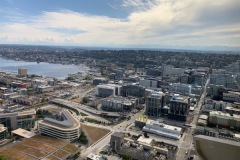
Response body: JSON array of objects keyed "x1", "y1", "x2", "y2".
[{"x1": 0, "y1": 135, "x2": 79, "y2": 160}]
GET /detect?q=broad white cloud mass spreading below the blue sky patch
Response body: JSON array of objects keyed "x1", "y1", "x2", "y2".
[{"x1": 0, "y1": 0, "x2": 240, "y2": 47}]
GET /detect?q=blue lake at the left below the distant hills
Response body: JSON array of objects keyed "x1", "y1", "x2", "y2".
[{"x1": 0, "y1": 57, "x2": 88, "y2": 79}]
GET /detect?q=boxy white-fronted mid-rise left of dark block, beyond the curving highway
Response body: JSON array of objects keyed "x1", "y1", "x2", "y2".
[{"x1": 96, "y1": 84, "x2": 121, "y2": 98}]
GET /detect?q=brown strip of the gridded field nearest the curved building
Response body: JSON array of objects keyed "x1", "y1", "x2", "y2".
[{"x1": 32, "y1": 135, "x2": 66, "y2": 147}]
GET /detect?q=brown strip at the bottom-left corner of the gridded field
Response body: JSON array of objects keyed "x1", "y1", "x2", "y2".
[{"x1": 0, "y1": 148, "x2": 34, "y2": 160}]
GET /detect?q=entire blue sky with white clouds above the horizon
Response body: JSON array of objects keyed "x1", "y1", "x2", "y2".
[{"x1": 0, "y1": 0, "x2": 240, "y2": 50}]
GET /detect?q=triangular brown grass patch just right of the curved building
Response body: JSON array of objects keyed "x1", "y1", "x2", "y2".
[{"x1": 81, "y1": 124, "x2": 110, "y2": 144}]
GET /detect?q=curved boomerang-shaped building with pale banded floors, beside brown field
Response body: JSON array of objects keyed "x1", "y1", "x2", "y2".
[{"x1": 38, "y1": 110, "x2": 80, "y2": 141}]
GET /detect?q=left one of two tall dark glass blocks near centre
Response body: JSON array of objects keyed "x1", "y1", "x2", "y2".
[{"x1": 146, "y1": 92, "x2": 166, "y2": 117}]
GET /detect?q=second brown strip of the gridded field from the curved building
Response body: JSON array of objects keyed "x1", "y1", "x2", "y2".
[{"x1": 22, "y1": 139, "x2": 57, "y2": 153}]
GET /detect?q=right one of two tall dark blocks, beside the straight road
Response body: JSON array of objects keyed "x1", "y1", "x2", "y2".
[{"x1": 168, "y1": 94, "x2": 190, "y2": 121}]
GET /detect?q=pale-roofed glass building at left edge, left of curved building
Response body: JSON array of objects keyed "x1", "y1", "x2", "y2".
[{"x1": 0, "y1": 110, "x2": 36, "y2": 129}]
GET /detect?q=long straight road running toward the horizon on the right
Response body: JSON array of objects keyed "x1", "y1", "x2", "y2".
[{"x1": 176, "y1": 77, "x2": 210, "y2": 160}]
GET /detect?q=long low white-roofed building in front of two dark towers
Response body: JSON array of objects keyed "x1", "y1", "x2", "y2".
[{"x1": 143, "y1": 120, "x2": 182, "y2": 139}]
